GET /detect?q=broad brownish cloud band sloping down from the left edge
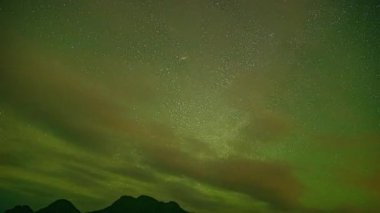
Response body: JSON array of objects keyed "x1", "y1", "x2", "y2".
[{"x1": 0, "y1": 36, "x2": 160, "y2": 153}]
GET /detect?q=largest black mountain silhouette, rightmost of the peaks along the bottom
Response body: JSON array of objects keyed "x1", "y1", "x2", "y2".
[{"x1": 89, "y1": 195, "x2": 187, "y2": 213}]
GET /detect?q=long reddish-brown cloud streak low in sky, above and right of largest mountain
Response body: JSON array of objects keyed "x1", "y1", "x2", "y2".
[{"x1": 132, "y1": 128, "x2": 303, "y2": 209}]
